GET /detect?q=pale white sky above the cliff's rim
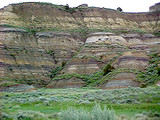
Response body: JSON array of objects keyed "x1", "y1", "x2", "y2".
[{"x1": 0, "y1": 0, "x2": 160, "y2": 12}]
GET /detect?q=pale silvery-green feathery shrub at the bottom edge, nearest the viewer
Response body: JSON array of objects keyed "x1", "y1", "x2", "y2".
[{"x1": 59, "y1": 104, "x2": 115, "y2": 120}]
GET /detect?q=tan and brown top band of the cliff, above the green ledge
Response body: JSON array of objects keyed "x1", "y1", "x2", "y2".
[{"x1": 0, "y1": 3, "x2": 160, "y2": 31}]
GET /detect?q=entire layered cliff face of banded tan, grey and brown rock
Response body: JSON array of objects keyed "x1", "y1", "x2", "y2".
[{"x1": 0, "y1": 3, "x2": 160, "y2": 88}]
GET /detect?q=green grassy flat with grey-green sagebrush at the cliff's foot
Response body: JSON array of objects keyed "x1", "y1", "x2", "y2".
[{"x1": 0, "y1": 87, "x2": 160, "y2": 120}]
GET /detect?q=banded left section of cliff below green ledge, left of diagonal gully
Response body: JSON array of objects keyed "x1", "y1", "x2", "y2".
[{"x1": 0, "y1": 26, "x2": 81, "y2": 86}]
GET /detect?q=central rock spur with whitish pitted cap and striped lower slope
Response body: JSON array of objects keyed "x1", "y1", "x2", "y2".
[{"x1": 64, "y1": 32, "x2": 127, "y2": 74}]
